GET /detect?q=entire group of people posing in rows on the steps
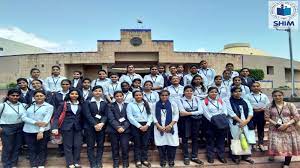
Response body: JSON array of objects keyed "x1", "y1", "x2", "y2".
[{"x1": 0, "y1": 60, "x2": 300, "y2": 168}]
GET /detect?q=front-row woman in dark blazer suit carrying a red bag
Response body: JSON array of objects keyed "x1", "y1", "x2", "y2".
[{"x1": 52, "y1": 88, "x2": 83, "y2": 168}]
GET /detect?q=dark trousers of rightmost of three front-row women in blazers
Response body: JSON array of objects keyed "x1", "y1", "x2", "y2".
[{"x1": 109, "y1": 133, "x2": 130, "y2": 164}]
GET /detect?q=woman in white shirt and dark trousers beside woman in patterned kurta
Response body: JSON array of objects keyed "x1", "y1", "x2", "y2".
[{"x1": 245, "y1": 82, "x2": 270, "y2": 152}]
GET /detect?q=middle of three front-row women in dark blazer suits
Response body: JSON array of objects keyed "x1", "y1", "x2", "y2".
[{"x1": 83, "y1": 86, "x2": 108, "y2": 168}]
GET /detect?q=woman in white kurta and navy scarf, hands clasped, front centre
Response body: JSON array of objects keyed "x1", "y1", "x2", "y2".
[{"x1": 153, "y1": 90, "x2": 179, "y2": 167}]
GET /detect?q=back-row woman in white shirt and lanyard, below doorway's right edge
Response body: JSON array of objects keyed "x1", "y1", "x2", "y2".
[{"x1": 144, "y1": 65, "x2": 164, "y2": 92}]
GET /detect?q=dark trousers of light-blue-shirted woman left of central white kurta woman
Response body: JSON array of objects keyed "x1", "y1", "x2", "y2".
[{"x1": 131, "y1": 125, "x2": 150, "y2": 162}]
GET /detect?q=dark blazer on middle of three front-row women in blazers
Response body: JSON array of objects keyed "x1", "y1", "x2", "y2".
[{"x1": 83, "y1": 100, "x2": 107, "y2": 130}]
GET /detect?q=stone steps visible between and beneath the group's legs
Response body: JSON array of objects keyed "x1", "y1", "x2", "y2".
[{"x1": 0, "y1": 109, "x2": 300, "y2": 168}]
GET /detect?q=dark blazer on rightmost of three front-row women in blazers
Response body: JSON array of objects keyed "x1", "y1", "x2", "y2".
[{"x1": 107, "y1": 102, "x2": 130, "y2": 133}]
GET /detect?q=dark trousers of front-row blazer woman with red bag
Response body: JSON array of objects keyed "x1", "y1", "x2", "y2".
[{"x1": 61, "y1": 127, "x2": 82, "y2": 166}]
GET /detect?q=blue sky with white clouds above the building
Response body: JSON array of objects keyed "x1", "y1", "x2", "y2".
[{"x1": 0, "y1": 0, "x2": 300, "y2": 61}]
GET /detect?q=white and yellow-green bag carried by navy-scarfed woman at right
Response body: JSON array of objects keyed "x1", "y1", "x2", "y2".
[{"x1": 230, "y1": 131, "x2": 251, "y2": 155}]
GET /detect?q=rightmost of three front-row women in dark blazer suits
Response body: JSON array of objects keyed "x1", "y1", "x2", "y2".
[{"x1": 107, "y1": 91, "x2": 130, "y2": 168}]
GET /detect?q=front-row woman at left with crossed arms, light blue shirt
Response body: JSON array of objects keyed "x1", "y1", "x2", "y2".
[{"x1": 22, "y1": 90, "x2": 54, "y2": 167}]
